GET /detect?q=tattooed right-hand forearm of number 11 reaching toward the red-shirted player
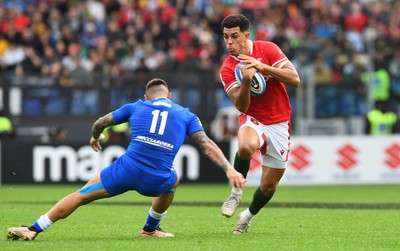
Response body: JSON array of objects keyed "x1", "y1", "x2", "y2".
[{"x1": 192, "y1": 131, "x2": 246, "y2": 189}]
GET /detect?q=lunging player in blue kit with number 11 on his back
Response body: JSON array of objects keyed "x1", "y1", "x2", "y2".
[{"x1": 8, "y1": 78, "x2": 246, "y2": 240}]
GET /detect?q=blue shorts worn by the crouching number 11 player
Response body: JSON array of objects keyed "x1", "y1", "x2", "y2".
[{"x1": 100, "y1": 154, "x2": 178, "y2": 197}]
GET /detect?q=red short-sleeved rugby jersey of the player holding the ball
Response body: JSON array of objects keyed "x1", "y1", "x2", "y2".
[{"x1": 219, "y1": 40, "x2": 292, "y2": 125}]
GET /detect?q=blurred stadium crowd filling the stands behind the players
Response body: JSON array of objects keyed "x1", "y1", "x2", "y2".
[{"x1": 0, "y1": 0, "x2": 400, "y2": 122}]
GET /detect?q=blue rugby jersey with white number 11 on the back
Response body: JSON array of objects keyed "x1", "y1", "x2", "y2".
[{"x1": 111, "y1": 98, "x2": 204, "y2": 173}]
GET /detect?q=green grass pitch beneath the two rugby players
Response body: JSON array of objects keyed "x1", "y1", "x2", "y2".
[{"x1": 0, "y1": 184, "x2": 400, "y2": 251}]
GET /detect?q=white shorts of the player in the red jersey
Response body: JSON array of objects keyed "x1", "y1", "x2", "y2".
[{"x1": 240, "y1": 114, "x2": 290, "y2": 169}]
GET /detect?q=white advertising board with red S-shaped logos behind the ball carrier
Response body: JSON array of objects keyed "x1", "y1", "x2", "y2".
[{"x1": 231, "y1": 135, "x2": 400, "y2": 186}]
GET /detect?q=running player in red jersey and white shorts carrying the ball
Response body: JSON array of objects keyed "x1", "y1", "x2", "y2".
[{"x1": 220, "y1": 14, "x2": 300, "y2": 234}]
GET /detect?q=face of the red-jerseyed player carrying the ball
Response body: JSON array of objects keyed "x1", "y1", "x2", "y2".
[{"x1": 223, "y1": 27, "x2": 250, "y2": 56}]
